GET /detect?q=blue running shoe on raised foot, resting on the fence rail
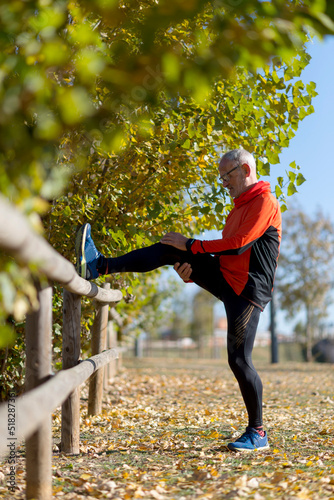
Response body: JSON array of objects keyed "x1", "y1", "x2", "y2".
[{"x1": 75, "y1": 223, "x2": 102, "y2": 280}]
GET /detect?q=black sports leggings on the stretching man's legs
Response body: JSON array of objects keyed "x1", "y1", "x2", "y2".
[{"x1": 107, "y1": 243, "x2": 262, "y2": 427}]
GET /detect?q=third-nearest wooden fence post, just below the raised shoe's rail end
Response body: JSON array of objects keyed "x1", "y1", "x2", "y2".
[{"x1": 88, "y1": 283, "x2": 110, "y2": 415}]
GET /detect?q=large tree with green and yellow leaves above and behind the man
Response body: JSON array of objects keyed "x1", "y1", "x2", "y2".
[{"x1": 0, "y1": 0, "x2": 333, "y2": 348}]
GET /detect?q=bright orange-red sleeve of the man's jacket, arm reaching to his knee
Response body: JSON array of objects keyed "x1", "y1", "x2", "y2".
[{"x1": 190, "y1": 196, "x2": 279, "y2": 255}]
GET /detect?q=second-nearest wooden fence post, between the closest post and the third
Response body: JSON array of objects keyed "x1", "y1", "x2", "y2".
[{"x1": 61, "y1": 289, "x2": 81, "y2": 455}]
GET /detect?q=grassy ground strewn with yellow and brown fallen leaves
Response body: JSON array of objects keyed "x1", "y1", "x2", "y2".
[{"x1": 0, "y1": 359, "x2": 334, "y2": 500}]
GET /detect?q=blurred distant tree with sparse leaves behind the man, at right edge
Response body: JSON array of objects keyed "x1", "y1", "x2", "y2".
[{"x1": 277, "y1": 208, "x2": 334, "y2": 361}]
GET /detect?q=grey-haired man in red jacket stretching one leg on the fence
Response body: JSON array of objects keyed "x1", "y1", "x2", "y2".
[{"x1": 76, "y1": 149, "x2": 281, "y2": 452}]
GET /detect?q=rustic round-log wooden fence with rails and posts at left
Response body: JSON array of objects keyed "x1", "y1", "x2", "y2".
[{"x1": 0, "y1": 196, "x2": 122, "y2": 500}]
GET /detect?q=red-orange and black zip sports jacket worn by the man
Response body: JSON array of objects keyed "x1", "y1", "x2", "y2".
[{"x1": 187, "y1": 181, "x2": 282, "y2": 309}]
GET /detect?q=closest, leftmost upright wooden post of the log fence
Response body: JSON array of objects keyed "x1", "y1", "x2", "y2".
[{"x1": 25, "y1": 286, "x2": 52, "y2": 500}]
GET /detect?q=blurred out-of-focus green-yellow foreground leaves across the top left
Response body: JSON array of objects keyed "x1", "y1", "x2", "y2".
[{"x1": 0, "y1": 0, "x2": 333, "y2": 203}]
